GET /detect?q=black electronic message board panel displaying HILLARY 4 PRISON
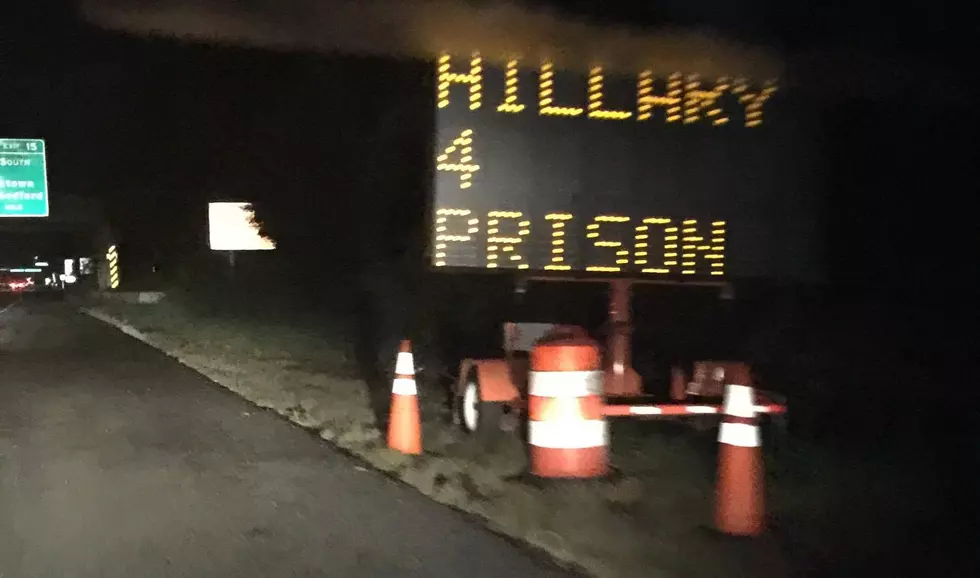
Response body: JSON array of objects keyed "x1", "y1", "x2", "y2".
[{"x1": 431, "y1": 54, "x2": 821, "y2": 281}]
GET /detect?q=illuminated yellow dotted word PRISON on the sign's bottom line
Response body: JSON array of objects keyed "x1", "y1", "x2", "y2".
[{"x1": 433, "y1": 208, "x2": 726, "y2": 276}]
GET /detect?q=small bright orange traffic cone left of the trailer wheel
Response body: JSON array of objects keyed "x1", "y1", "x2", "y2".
[{"x1": 388, "y1": 339, "x2": 422, "y2": 455}]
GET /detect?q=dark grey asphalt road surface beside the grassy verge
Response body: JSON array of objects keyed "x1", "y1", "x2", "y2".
[{"x1": 0, "y1": 300, "x2": 570, "y2": 578}]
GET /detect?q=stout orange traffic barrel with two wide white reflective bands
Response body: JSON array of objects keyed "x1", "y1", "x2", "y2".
[{"x1": 528, "y1": 337, "x2": 609, "y2": 479}]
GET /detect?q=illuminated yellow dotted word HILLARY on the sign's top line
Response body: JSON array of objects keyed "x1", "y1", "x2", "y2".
[{"x1": 436, "y1": 54, "x2": 776, "y2": 127}]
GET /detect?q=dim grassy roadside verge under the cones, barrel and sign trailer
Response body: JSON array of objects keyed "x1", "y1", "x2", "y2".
[{"x1": 82, "y1": 300, "x2": 933, "y2": 578}]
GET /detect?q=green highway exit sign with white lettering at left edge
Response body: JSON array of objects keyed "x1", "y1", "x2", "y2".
[{"x1": 0, "y1": 138, "x2": 49, "y2": 217}]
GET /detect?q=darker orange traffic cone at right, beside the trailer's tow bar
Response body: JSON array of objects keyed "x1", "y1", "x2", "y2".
[{"x1": 715, "y1": 366, "x2": 765, "y2": 536}]
